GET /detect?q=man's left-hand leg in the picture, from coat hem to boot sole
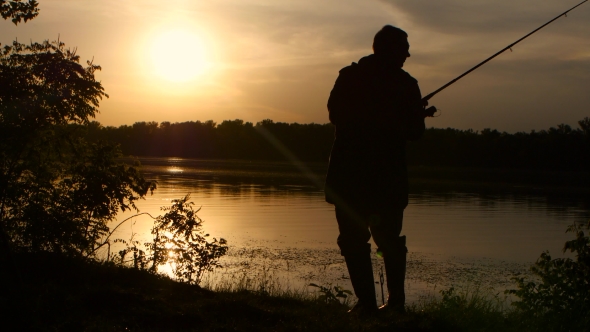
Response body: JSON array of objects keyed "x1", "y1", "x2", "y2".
[{"x1": 336, "y1": 207, "x2": 377, "y2": 313}]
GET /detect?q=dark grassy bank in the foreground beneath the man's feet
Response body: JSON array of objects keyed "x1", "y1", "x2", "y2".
[{"x1": 0, "y1": 254, "x2": 540, "y2": 331}]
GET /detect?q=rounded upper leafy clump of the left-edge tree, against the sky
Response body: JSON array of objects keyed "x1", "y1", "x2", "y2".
[{"x1": 0, "y1": 41, "x2": 108, "y2": 127}]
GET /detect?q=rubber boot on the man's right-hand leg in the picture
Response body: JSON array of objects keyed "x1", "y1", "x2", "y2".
[{"x1": 379, "y1": 236, "x2": 408, "y2": 313}]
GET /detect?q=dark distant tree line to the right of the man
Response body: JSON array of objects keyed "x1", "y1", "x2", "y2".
[{"x1": 408, "y1": 117, "x2": 590, "y2": 171}]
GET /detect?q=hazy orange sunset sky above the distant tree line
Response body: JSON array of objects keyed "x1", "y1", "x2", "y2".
[{"x1": 0, "y1": 0, "x2": 590, "y2": 132}]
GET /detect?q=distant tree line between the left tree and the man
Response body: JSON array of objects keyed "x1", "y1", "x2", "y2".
[{"x1": 89, "y1": 120, "x2": 334, "y2": 161}]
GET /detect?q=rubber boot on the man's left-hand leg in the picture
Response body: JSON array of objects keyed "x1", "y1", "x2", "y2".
[{"x1": 344, "y1": 249, "x2": 377, "y2": 315}]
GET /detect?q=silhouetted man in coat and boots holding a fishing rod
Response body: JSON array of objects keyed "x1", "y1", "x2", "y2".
[{"x1": 326, "y1": 25, "x2": 432, "y2": 313}]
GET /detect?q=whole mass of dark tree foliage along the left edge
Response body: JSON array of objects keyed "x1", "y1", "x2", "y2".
[{"x1": 0, "y1": 41, "x2": 155, "y2": 255}]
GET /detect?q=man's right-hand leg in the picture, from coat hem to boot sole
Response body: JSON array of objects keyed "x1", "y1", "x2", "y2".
[{"x1": 370, "y1": 209, "x2": 408, "y2": 311}]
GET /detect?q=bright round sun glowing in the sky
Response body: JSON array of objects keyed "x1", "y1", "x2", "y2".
[{"x1": 151, "y1": 30, "x2": 208, "y2": 82}]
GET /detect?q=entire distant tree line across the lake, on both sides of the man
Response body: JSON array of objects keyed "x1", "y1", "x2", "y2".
[{"x1": 88, "y1": 117, "x2": 590, "y2": 171}]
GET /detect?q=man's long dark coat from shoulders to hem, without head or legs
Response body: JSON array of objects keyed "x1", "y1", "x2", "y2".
[{"x1": 326, "y1": 55, "x2": 424, "y2": 208}]
